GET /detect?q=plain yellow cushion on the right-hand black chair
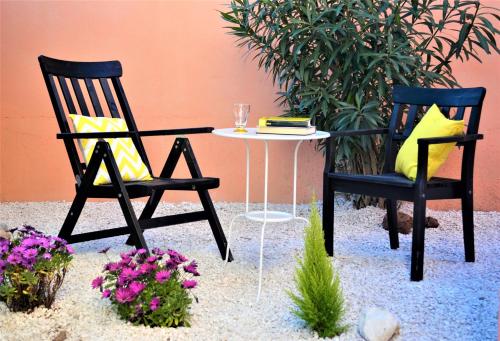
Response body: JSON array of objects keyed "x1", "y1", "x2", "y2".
[{"x1": 396, "y1": 104, "x2": 464, "y2": 180}]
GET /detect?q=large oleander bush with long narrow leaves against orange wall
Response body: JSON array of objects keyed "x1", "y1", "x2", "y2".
[{"x1": 221, "y1": 0, "x2": 500, "y2": 206}]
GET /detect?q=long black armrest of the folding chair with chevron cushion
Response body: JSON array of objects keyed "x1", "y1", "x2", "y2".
[{"x1": 57, "y1": 127, "x2": 214, "y2": 140}]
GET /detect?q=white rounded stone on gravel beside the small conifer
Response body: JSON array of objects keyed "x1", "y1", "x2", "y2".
[{"x1": 358, "y1": 307, "x2": 399, "y2": 341}]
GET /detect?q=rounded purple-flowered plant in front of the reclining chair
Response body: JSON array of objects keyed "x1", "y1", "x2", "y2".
[{"x1": 91, "y1": 248, "x2": 200, "y2": 327}]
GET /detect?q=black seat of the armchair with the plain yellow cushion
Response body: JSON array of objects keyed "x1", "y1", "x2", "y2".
[{"x1": 329, "y1": 173, "x2": 460, "y2": 188}]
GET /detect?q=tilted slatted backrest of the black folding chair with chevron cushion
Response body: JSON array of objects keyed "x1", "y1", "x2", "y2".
[{"x1": 38, "y1": 56, "x2": 152, "y2": 179}]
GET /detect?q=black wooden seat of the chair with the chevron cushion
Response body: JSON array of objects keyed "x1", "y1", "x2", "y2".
[{"x1": 90, "y1": 177, "x2": 219, "y2": 198}]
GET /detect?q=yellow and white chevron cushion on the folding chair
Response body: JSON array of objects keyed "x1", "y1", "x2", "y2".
[{"x1": 69, "y1": 115, "x2": 153, "y2": 186}]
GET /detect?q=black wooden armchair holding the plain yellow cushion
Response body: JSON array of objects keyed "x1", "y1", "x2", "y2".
[{"x1": 323, "y1": 86, "x2": 486, "y2": 281}]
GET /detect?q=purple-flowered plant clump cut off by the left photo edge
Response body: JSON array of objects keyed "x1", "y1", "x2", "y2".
[{"x1": 0, "y1": 226, "x2": 74, "y2": 312}]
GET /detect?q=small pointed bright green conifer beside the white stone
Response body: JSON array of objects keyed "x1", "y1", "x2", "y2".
[{"x1": 288, "y1": 201, "x2": 347, "y2": 337}]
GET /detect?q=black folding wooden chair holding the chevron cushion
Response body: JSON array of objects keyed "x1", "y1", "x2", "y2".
[{"x1": 38, "y1": 56, "x2": 232, "y2": 259}]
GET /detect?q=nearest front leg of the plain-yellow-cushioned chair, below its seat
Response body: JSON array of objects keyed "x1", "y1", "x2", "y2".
[{"x1": 410, "y1": 196, "x2": 426, "y2": 281}]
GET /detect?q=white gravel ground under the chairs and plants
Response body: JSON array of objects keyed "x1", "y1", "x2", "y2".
[{"x1": 0, "y1": 202, "x2": 500, "y2": 341}]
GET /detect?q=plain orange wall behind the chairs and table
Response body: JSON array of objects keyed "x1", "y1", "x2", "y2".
[{"x1": 0, "y1": 0, "x2": 500, "y2": 210}]
